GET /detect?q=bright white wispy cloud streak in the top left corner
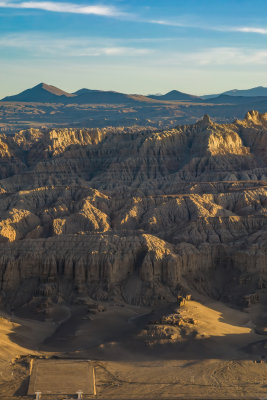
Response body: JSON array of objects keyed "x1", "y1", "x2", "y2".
[{"x1": 0, "y1": 0, "x2": 125, "y2": 17}]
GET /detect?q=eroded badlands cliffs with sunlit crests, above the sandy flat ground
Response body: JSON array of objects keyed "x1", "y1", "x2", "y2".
[{"x1": 0, "y1": 111, "x2": 267, "y2": 307}]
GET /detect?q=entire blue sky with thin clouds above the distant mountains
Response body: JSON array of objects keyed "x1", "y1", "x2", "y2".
[{"x1": 0, "y1": 0, "x2": 267, "y2": 98}]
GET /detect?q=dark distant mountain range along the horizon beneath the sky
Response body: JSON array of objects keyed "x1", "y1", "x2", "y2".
[{"x1": 1, "y1": 83, "x2": 267, "y2": 104}]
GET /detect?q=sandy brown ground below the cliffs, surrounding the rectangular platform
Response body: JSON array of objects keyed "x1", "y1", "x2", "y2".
[{"x1": 0, "y1": 298, "x2": 267, "y2": 399}]
